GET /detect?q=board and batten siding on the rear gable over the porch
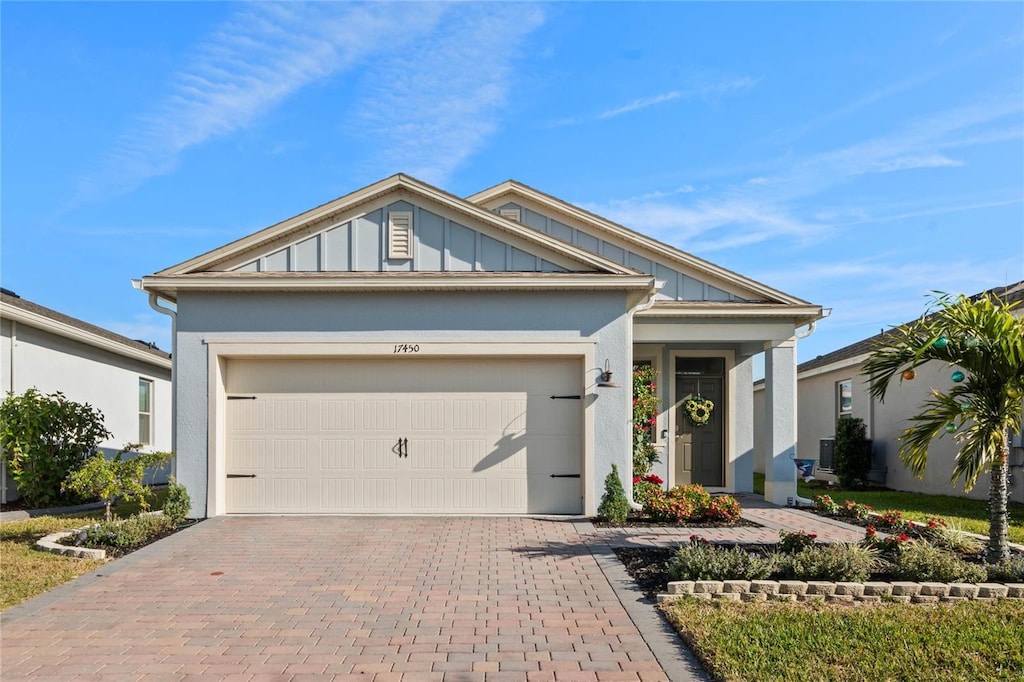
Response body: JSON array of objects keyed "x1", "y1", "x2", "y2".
[{"x1": 495, "y1": 202, "x2": 744, "y2": 301}]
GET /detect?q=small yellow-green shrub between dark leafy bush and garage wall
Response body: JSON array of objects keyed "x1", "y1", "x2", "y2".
[{"x1": 65, "y1": 443, "x2": 173, "y2": 521}]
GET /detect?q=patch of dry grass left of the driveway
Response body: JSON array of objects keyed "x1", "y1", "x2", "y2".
[{"x1": 0, "y1": 491, "x2": 166, "y2": 610}]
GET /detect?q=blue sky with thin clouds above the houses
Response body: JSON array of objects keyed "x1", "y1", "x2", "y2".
[{"x1": 0, "y1": 2, "x2": 1024, "y2": 360}]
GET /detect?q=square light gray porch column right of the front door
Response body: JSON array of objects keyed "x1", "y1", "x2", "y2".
[{"x1": 765, "y1": 338, "x2": 797, "y2": 506}]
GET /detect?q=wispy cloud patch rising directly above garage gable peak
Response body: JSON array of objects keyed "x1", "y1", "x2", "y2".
[{"x1": 353, "y1": 3, "x2": 545, "y2": 184}]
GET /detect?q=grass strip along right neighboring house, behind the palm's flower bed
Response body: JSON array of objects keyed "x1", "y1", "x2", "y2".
[{"x1": 754, "y1": 473, "x2": 1024, "y2": 545}]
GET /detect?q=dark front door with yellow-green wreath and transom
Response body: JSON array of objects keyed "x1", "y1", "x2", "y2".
[{"x1": 674, "y1": 357, "x2": 726, "y2": 485}]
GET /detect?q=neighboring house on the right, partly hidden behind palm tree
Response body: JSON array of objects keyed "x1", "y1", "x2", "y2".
[{"x1": 755, "y1": 282, "x2": 1024, "y2": 502}]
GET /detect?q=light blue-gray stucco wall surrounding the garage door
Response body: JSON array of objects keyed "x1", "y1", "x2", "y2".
[{"x1": 175, "y1": 292, "x2": 632, "y2": 516}]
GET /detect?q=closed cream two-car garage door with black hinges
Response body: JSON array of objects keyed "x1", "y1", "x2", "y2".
[{"x1": 225, "y1": 358, "x2": 583, "y2": 514}]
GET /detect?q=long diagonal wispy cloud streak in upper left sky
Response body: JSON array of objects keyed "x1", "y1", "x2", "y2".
[{"x1": 76, "y1": 3, "x2": 445, "y2": 203}]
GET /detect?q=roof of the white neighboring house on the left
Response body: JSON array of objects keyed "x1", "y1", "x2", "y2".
[{"x1": 0, "y1": 291, "x2": 171, "y2": 369}]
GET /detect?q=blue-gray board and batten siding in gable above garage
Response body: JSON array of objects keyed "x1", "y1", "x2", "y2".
[{"x1": 234, "y1": 201, "x2": 565, "y2": 272}]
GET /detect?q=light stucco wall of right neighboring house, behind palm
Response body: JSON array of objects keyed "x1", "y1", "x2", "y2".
[{"x1": 755, "y1": 363, "x2": 1024, "y2": 502}]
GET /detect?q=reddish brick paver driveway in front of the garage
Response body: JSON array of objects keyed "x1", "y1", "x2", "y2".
[{"x1": 0, "y1": 517, "x2": 666, "y2": 682}]
